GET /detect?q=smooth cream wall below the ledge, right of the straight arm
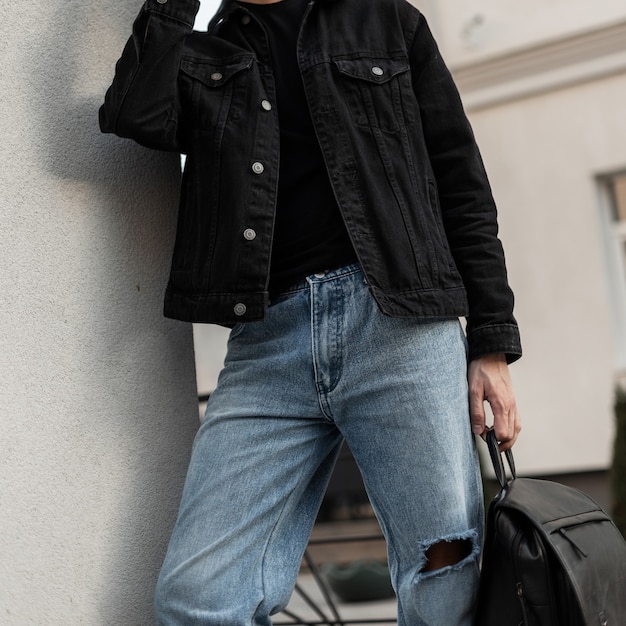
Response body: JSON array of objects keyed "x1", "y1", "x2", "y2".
[{"x1": 471, "y1": 75, "x2": 626, "y2": 472}]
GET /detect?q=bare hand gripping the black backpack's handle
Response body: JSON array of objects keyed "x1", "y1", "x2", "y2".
[{"x1": 467, "y1": 354, "x2": 522, "y2": 451}]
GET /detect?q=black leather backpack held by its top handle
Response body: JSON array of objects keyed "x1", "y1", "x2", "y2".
[{"x1": 475, "y1": 431, "x2": 626, "y2": 626}]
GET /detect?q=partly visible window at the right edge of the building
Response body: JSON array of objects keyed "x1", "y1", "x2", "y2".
[{"x1": 599, "y1": 172, "x2": 626, "y2": 373}]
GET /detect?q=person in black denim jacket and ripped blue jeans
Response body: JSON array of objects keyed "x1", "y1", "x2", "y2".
[{"x1": 100, "y1": 0, "x2": 521, "y2": 626}]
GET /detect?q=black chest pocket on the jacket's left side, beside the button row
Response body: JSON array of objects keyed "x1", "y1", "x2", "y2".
[{"x1": 179, "y1": 57, "x2": 253, "y2": 130}]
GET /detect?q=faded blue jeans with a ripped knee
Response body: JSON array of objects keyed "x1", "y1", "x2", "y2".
[{"x1": 156, "y1": 265, "x2": 483, "y2": 626}]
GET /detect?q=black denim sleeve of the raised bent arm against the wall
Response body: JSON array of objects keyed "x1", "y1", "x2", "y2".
[{"x1": 99, "y1": 0, "x2": 200, "y2": 152}]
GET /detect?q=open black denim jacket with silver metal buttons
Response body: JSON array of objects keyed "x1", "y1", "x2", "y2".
[{"x1": 100, "y1": 0, "x2": 521, "y2": 361}]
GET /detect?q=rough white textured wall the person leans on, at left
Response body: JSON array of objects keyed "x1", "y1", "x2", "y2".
[{"x1": 0, "y1": 0, "x2": 197, "y2": 626}]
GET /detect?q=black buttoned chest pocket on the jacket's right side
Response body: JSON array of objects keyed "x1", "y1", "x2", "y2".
[{"x1": 334, "y1": 57, "x2": 414, "y2": 132}]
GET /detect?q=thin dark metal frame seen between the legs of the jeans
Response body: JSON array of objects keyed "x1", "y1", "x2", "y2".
[{"x1": 275, "y1": 534, "x2": 398, "y2": 626}]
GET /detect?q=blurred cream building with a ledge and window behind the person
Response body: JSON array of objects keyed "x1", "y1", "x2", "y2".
[{"x1": 195, "y1": 0, "x2": 626, "y2": 474}]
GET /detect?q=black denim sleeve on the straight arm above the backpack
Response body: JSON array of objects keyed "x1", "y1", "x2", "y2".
[{"x1": 410, "y1": 15, "x2": 522, "y2": 362}]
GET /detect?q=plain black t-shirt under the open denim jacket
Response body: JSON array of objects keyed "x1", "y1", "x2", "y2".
[{"x1": 240, "y1": 0, "x2": 356, "y2": 294}]
